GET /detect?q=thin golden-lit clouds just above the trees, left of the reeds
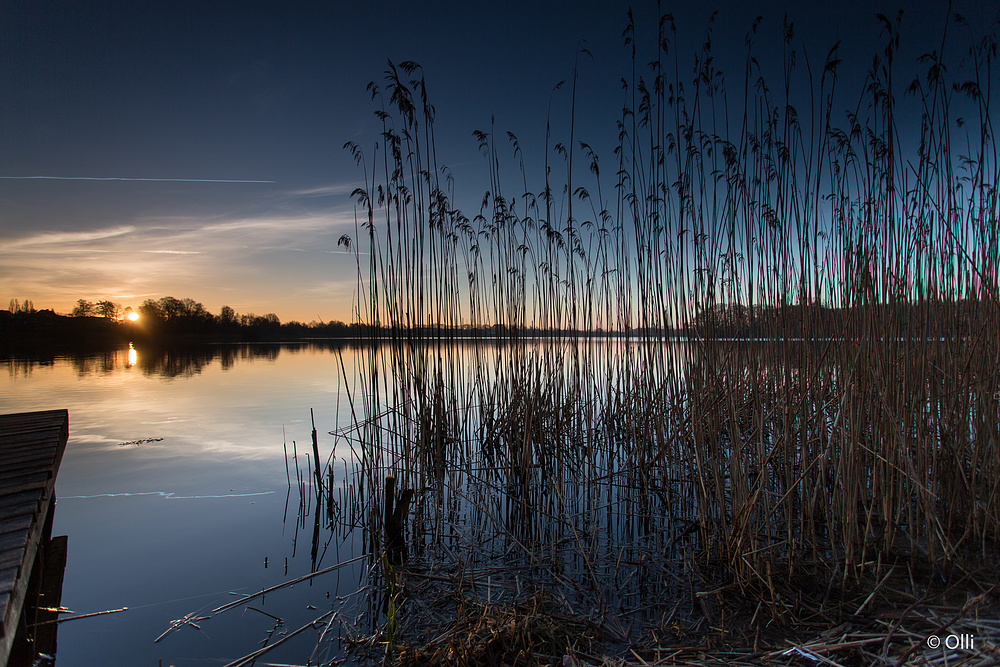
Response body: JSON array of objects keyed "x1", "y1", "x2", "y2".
[{"x1": 0, "y1": 210, "x2": 356, "y2": 319}]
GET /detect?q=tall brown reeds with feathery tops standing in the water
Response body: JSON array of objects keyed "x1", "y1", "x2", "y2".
[{"x1": 316, "y1": 7, "x2": 1000, "y2": 664}]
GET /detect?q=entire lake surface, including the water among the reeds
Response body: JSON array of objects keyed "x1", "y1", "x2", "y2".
[{"x1": 0, "y1": 337, "x2": 998, "y2": 667}]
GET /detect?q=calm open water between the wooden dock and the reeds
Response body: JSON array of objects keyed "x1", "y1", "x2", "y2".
[{"x1": 0, "y1": 345, "x2": 364, "y2": 667}]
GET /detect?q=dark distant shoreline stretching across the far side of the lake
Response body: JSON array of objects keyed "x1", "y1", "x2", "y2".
[{"x1": 0, "y1": 303, "x2": 982, "y2": 357}]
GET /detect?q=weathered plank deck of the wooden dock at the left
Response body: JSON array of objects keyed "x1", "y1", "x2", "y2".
[{"x1": 0, "y1": 410, "x2": 69, "y2": 665}]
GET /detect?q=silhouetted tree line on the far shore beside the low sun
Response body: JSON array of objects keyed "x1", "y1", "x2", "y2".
[{"x1": 9, "y1": 296, "x2": 1000, "y2": 351}]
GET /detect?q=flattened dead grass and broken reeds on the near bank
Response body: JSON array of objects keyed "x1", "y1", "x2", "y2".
[{"x1": 346, "y1": 571, "x2": 1000, "y2": 667}]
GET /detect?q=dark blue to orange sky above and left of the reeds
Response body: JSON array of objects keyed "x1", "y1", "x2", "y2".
[{"x1": 0, "y1": 0, "x2": 1000, "y2": 322}]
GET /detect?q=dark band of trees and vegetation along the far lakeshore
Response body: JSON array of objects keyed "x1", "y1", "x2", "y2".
[{"x1": 0, "y1": 297, "x2": 989, "y2": 355}]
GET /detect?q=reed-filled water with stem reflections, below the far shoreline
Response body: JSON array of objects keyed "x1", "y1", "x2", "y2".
[{"x1": 334, "y1": 338, "x2": 1000, "y2": 656}]
